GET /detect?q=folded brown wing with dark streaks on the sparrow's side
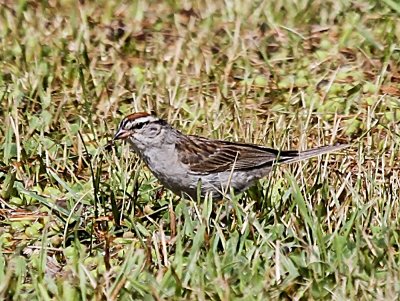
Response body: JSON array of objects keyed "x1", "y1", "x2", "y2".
[{"x1": 176, "y1": 136, "x2": 298, "y2": 173}]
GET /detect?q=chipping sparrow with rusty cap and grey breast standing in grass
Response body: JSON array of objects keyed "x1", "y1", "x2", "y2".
[{"x1": 114, "y1": 112, "x2": 348, "y2": 198}]
